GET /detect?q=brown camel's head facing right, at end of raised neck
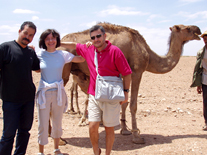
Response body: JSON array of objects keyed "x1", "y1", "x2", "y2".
[{"x1": 170, "y1": 25, "x2": 201, "y2": 42}]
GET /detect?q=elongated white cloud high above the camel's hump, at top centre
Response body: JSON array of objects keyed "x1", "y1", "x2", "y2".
[{"x1": 100, "y1": 5, "x2": 149, "y2": 17}]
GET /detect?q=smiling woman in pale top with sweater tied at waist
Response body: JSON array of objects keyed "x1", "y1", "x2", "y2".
[{"x1": 36, "y1": 29, "x2": 85, "y2": 155}]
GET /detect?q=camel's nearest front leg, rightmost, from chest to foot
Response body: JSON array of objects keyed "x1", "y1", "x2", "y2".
[{"x1": 130, "y1": 72, "x2": 145, "y2": 144}]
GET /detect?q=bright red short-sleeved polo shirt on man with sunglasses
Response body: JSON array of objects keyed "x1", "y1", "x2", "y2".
[{"x1": 76, "y1": 40, "x2": 132, "y2": 95}]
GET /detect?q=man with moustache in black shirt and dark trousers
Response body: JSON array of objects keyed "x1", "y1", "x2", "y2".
[{"x1": 0, "y1": 22, "x2": 40, "y2": 155}]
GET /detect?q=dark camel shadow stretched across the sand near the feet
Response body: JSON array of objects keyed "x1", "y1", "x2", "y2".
[{"x1": 63, "y1": 126, "x2": 207, "y2": 151}]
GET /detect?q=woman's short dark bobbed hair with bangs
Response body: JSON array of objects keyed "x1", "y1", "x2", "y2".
[{"x1": 39, "y1": 29, "x2": 60, "y2": 50}]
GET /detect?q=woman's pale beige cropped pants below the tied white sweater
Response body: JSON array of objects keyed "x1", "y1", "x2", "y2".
[{"x1": 38, "y1": 90, "x2": 67, "y2": 145}]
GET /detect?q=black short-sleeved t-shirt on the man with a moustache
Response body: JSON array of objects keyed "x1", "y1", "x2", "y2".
[{"x1": 0, "y1": 41, "x2": 40, "y2": 103}]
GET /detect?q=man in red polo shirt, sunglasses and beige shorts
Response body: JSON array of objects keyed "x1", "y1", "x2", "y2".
[{"x1": 61, "y1": 25, "x2": 132, "y2": 155}]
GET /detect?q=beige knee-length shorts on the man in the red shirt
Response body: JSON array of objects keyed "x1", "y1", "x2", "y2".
[{"x1": 88, "y1": 94, "x2": 121, "y2": 127}]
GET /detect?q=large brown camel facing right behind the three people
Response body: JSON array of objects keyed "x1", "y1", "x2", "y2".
[{"x1": 61, "y1": 23, "x2": 201, "y2": 144}]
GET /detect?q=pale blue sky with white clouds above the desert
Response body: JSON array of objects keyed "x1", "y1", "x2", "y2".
[{"x1": 0, "y1": 0, "x2": 207, "y2": 56}]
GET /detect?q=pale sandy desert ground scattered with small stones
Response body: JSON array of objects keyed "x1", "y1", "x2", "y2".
[{"x1": 0, "y1": 57, "x2": 207, "y2": 155}]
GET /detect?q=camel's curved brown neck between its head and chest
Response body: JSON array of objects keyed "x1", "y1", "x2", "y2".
[{"x1": 146, "y1": 36, "x2": 183, "y2": 74}]
